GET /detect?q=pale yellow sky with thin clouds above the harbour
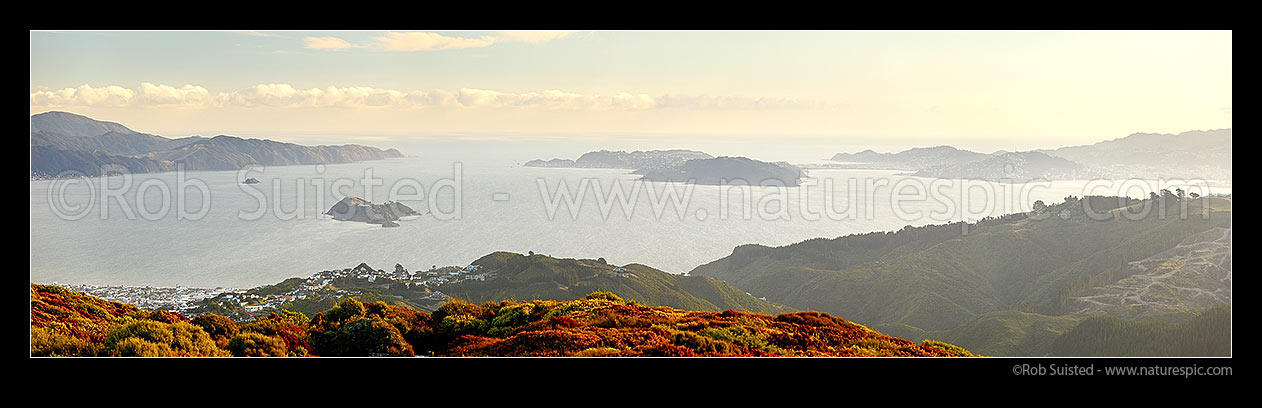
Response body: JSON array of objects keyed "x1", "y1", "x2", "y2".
[{"x1": 30, "y1": 30, "x2": 1232, "y2": 150}]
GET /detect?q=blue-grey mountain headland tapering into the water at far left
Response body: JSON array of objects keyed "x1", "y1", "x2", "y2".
[{"x1": 30, "y1": 111, "x2": 403, "y2": 177}]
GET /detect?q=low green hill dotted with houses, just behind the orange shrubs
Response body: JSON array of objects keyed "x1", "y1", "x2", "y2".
[{"x1": 191, "y1": 253, "x2": 794, "y2": 320}]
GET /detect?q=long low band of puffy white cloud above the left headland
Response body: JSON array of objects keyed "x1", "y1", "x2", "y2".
[{"x1": 30, "y1": 82, "x2": 818, "y2": 110}]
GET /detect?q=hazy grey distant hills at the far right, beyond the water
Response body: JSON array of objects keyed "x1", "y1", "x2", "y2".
[{"x1": 830, "y1": 129, "x2": 1232, "y2": 182}]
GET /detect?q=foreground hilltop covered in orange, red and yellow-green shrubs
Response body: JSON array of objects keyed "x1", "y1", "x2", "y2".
[{"x1": 30, "y1": 284, "x2": 972, "y2": 356}]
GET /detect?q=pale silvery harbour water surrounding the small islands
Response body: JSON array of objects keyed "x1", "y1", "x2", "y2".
[{"x1": 30, "y1": 139, "x2": 1230, "y2": 288}]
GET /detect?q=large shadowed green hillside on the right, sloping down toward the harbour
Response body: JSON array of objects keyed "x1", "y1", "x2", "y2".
[{"x1": 690, "y1": 197, "x2": 1230, "y2": 350}]
